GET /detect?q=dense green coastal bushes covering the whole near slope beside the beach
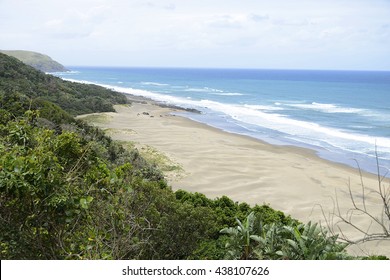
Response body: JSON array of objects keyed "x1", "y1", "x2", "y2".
[{"x1": 0, "y1": 54, "x2": 386, "y2": 259}]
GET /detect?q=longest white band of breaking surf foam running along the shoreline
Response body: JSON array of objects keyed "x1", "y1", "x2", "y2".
[{"x1": 61, "y1": 79, "x2": 390, "y2": 160}]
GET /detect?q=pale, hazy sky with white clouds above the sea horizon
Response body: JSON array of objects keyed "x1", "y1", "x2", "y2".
[{"x1": 0, "y1": 0, "x2": 390, "y2": 71}]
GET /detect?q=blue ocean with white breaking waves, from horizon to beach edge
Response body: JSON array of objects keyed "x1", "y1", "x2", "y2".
[{"x1": 55, "y1": 67, "x2": 390, "y2": 175}]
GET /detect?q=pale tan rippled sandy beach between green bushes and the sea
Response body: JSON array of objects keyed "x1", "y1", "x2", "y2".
[{"x1": 81, "y1": 101, "x2": 390, "y2": 255}]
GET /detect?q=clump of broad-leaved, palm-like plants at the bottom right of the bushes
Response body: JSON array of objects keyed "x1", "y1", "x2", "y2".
[{"x1": 221, "y1": 212, "x2": 348, "y2": 260}]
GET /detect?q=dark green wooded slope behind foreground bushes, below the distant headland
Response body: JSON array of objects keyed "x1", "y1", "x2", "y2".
[{"x1": 0, "y1": 53, "x2": 128, "y2": 116}]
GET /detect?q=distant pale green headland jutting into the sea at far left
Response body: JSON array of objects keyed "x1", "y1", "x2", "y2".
[{"x1": 0, "y1": 50, "x2": 68, "y2": 72}]
